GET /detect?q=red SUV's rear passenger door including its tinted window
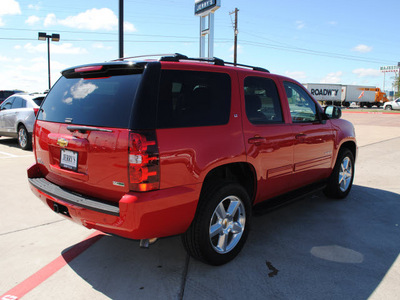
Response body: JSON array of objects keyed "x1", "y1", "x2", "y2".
[{"x1": 241, "y1": 74, "x2": 293, "y2": 202}]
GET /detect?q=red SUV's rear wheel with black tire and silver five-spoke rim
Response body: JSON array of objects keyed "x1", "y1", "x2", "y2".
[{"x1": 182, "y1": 182, "x2": 251, "y2": 266}]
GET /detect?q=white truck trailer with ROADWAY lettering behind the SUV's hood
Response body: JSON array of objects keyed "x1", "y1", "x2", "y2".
[{"x1": 303, "y1": 83, "x2": 342, "y2": 106}]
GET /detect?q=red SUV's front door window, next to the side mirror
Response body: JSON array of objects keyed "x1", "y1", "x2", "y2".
[{"x1": 284, "y1": 81, "x2": 319, "y2": 123}]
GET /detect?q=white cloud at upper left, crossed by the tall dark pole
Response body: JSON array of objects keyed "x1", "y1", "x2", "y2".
[{"x1": 54, "y1": 8, "x2": 136, "y2": 32}]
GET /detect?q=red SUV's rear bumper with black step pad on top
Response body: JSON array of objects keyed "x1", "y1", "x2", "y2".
[{"x1": 28, "y1": 164, "x2": 201, "y2": 239}]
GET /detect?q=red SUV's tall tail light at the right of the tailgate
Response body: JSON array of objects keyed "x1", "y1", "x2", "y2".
[{"x1": 128, "y1": 130, "x2": 160, "y2": 192}]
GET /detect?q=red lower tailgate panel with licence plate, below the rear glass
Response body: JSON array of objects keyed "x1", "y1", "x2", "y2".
[{"x1": 35, "y1": 121, "x2": 129, "y2": 201}]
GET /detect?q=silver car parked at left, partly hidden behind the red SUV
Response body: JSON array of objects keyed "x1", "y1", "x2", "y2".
[{"x1": 0, "y1": 94, "x2": 46, "y2": 150}]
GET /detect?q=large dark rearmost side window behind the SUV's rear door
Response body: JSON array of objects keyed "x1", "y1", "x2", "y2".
[{"x1": 157, "y1": 70, "x2": 231, "y2": 128}]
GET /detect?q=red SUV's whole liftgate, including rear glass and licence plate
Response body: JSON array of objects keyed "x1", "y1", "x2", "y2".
[{"x1": 35, "y1": 70, "x2": 142, "y2": 201}]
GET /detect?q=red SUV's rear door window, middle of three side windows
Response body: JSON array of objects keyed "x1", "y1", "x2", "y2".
[{"x1": 244, "y1": 77, "x2": 283, "y2": 124}]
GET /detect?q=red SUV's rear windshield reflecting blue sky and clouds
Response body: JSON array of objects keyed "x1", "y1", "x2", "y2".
[{"x1": 38, "y1": 74, "x2": 142, "y2": 128}]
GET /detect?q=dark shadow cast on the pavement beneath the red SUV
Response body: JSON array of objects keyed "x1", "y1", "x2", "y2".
[{"x1": 62, "y1": 186, "x2": 400, "y2": 299}]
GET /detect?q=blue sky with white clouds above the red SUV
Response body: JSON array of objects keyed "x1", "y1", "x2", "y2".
[{"x1": 0, "y1": 0, "x2": 400, "y2": 92}]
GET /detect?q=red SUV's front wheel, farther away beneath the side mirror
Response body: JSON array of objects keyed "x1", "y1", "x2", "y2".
[{"x1": 324, "y1": 148, "x2": 354, "y2": 199}]
